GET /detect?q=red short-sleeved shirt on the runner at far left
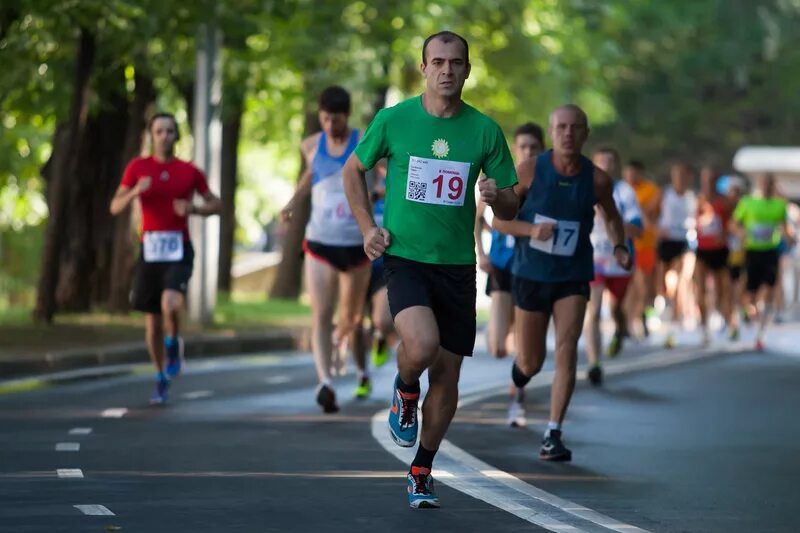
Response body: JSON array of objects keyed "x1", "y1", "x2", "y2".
[{"x1": 120, "y1": 157, "x2": 208, "y2": 240}]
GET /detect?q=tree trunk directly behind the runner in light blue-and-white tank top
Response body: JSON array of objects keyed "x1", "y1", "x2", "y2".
[{"x1": 269, "y1": 111, "x2": 320, "y2": 299}]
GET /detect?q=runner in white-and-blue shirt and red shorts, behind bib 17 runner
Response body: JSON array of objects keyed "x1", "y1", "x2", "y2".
[{"x1": 583, "y1": 148, "x2": 644, "y2": 385}]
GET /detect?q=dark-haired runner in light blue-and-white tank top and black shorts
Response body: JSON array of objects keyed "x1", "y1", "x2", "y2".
[{"x1": 281, "y1": 86, "x2": 371, "y2": 413}]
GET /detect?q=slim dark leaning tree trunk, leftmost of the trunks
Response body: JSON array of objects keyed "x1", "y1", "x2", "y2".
[{"x1": 33, "y1": 28, "x2": 96, "y2": 323}]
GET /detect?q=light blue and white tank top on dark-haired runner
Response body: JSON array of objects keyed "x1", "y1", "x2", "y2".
[{"x1": 306, "y1": 129, "x2": 363, "y2": 246}]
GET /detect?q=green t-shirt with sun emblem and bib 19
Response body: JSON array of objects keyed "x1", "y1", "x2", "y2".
[{"x1": 355, "y1": 96, "x2": 517, "y2": 265}]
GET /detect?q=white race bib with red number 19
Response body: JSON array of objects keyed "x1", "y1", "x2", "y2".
[{"x1": 406, "y1": 156, "x2": 470, "y2": 206}]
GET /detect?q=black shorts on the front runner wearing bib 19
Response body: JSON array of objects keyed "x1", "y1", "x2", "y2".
[{"x1": 383, "y1": 255, "x2": 478, "y2": 356}]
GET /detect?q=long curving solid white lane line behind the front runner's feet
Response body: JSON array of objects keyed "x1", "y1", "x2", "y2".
[{"x1": 372, "y1": 348, "x2": 730, "y2": 533}]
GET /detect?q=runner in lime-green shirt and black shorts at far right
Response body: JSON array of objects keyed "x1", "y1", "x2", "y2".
[{"x1": 733, "y1": 174, "x2": 792, "y2": 351}]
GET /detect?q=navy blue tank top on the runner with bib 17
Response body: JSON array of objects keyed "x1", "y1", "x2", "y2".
[{"x1": 511, "y1": 150, "x2": 596, "y2": 283}]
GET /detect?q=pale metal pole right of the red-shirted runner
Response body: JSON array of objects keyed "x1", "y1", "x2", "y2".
[{"x1": 188, "y1": 25, "x2": 222, "y2": 324}]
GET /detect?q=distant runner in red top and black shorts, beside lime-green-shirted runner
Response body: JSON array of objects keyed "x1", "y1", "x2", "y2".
[{"x1": 694, "y1": 167, "x2": 733, "y2": 346}]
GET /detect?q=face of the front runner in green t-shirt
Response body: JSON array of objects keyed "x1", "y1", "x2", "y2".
[{"x1": 420, "y1": 39, "x2": 470, "y2": 98}]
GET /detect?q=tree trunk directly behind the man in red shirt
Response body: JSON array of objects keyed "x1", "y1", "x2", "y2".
[{"x1": 108, "y1": 68, "x2": 156, "y2": 312}]
